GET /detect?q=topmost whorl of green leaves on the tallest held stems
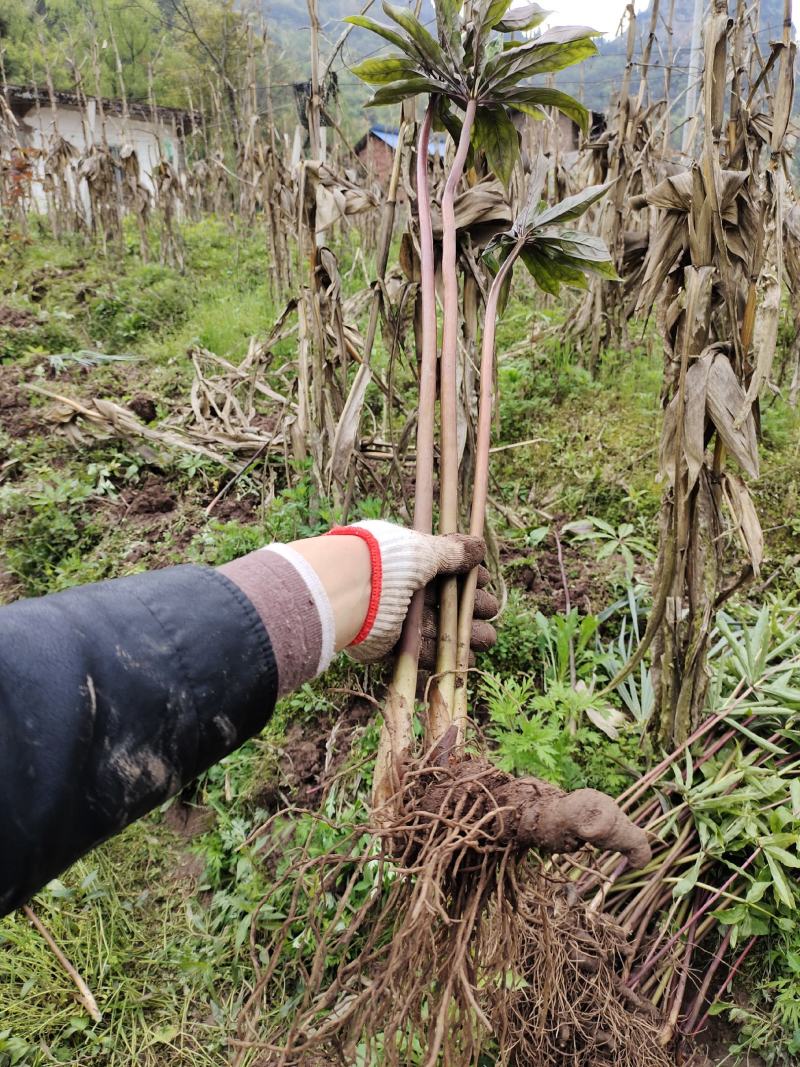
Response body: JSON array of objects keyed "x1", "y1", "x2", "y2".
[{"x1": 347, "y1": 0, "x2": 598, "y2": 186}]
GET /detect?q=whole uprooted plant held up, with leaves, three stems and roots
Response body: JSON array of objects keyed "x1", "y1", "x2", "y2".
[{"x1": 228, "y1": 0, "x2": 674, "y2": 1067}]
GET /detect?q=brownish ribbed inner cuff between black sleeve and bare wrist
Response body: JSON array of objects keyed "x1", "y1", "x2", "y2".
[{"x1": 218, "y1": 548, "x2": 322, "y2": 696}]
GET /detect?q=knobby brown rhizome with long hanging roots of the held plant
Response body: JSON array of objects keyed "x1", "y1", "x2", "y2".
[{"x1": 237, "y1": 750, "x2": 652, "y2": 1067}]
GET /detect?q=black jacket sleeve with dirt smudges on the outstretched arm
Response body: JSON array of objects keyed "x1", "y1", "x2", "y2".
[{"x1": 0, "y1": 567, "x2": 277, "y2": 914}]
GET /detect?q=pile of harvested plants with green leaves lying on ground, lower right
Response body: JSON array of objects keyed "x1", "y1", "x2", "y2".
[{"x1": 533, "y1": 601, "x2": 800, "y2": 1064}]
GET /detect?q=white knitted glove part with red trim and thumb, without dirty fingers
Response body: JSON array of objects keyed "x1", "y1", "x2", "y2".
[{"x1": 331, "y1": 520, "x2": 485, "y2": 663}]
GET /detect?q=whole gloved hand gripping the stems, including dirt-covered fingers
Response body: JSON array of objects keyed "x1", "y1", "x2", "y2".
[{"x1": 331, "y1": 520, "x2": 497, "y2": 669}]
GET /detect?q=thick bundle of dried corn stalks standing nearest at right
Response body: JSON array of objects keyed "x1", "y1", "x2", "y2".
[{"x1": 612, "y1": 0, "x2": 794, "y2": 747}]
